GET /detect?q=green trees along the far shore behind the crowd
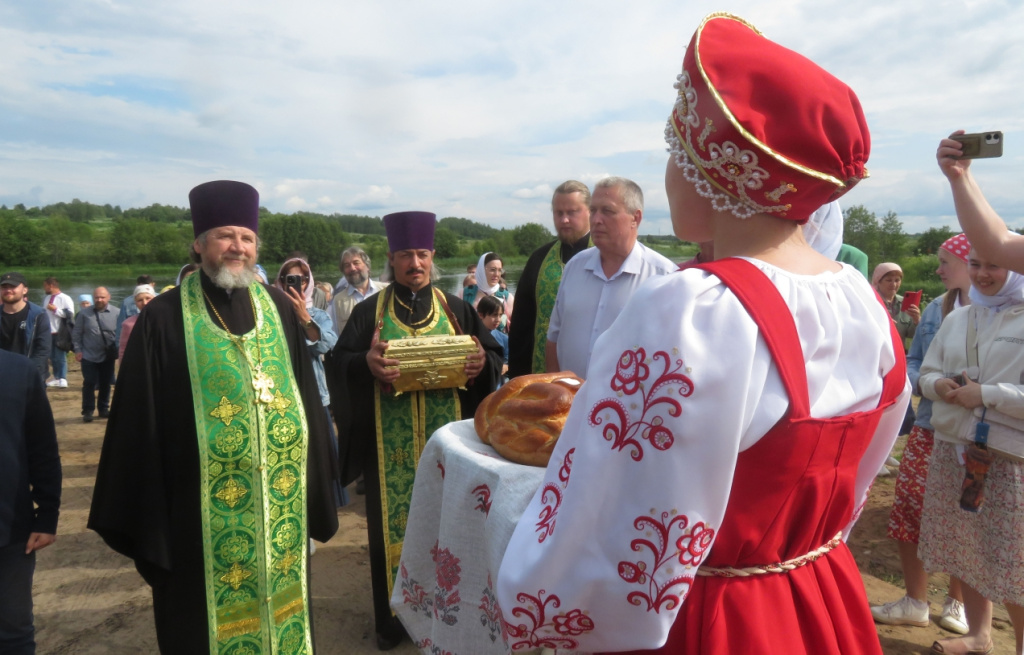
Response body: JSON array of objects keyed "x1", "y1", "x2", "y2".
[{"x1": 0, "y1": 199, "x2": 995, "y2": 298}]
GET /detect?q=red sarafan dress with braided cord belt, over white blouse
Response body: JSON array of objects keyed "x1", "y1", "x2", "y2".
[{"x1": 606, "y1": 257, "x2": 906, "y2": 655}]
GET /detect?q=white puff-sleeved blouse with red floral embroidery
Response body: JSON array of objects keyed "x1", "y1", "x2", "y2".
[{"x1": 497, "y1": 260, "x2": 909, "y2": 652}]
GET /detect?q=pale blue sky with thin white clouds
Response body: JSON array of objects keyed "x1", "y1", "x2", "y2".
[{"x1": 0, "y1": 0, "x2": 1024, "y2": 233}]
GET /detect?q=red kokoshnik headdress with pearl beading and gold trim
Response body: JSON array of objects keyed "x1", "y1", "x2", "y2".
[{"x1": 665, "y1": 13, "x2": 871, "y2": 223}]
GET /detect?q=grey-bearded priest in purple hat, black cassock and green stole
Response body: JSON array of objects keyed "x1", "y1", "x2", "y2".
[{"x1": 89, "y1": 181, "x2": 338, "y2": 654}]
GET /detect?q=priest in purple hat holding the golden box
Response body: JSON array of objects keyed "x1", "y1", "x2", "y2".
[{"x1": 333, "y1": 212, "x2": 502, "y2": 650}]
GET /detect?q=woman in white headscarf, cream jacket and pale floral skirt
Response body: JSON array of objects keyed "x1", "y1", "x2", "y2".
[{"x1": 919, "y1": 250, "x2": 1024, "y2": 655}]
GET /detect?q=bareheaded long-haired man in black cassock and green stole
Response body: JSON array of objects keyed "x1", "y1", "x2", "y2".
[{"x1": 509, "y1": 180, "x2": 590, "y2": 378}]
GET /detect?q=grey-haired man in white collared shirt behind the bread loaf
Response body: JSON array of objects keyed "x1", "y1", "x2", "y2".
[{"x1": 545, "y1": 177, "x2": 677, "y2": 379}]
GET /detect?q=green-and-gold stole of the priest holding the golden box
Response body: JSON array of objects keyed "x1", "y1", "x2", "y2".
[{"x1": 374, "y1": 290, "x2": 462, "y2": 596}]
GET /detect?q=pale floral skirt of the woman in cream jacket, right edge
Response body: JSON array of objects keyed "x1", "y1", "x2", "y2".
[{"x1": 918, "y1": 441, "x2": 1024, "y2": 605}]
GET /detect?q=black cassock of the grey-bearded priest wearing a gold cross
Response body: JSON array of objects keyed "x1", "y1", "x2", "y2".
[{"x1": 88, "y1": 271, "x2": 338, "y2": 654}]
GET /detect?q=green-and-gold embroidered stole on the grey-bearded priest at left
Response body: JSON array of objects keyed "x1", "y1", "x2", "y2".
[{"x1": 181, "y1": 275, "x2": 312, "y2": 655}]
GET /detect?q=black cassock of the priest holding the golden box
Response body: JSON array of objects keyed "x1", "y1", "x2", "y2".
[{"x1": 331, "y1": 282, "x2": 504, "y2": 642}]
